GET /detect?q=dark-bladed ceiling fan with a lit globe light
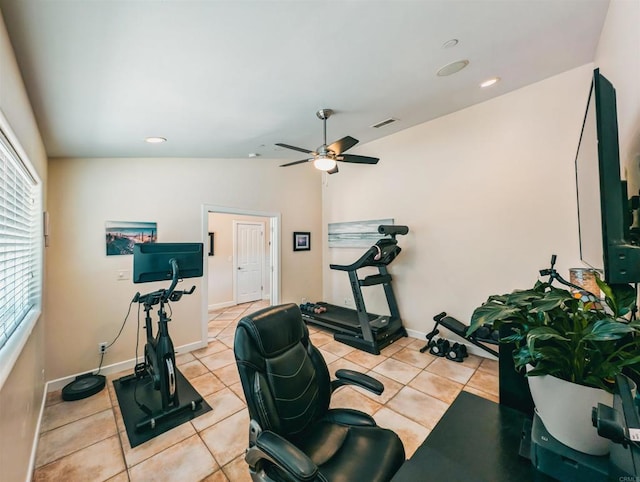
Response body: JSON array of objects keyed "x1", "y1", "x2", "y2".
[{"x1": 276, "y1": 109, "x2": 380, "y2": 174}]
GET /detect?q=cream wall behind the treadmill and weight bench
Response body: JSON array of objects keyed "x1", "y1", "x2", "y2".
[{"x1": 323, "y1": 65, "x2": 592, "y2": 340}]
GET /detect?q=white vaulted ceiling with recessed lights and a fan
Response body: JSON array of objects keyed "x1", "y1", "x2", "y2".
[{"x1": 0, "y1": 0, "x2": 608, "y2": 159}]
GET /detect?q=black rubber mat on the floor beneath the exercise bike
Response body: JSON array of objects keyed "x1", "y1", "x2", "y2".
[{"x1": 113, "y1": 370, "x2": 211, "y2": 448}]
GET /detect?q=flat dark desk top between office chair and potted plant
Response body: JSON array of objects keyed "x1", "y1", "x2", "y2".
[{"x1": 393, "y1": 392, "x2": 541, "y2": 482}]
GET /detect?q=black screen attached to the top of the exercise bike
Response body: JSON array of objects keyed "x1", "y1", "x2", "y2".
[{"x1": 133, "y1": 243, "x2": 204, "y2": 283}]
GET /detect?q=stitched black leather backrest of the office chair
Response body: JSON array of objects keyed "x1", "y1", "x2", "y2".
[{"x1": 234, "y1": 303, "x2": 331, "y2": 438}]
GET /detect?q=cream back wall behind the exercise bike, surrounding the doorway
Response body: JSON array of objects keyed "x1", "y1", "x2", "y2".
[{"x1": 46, "y1": 159, "x2": 321, "y2": 379}]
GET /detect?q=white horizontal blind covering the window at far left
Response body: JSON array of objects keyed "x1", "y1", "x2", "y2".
[{"x1": 0, "y1": 131, "x2": 41, "y2": 351}]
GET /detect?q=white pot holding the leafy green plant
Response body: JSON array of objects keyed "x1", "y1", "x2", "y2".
[{"x1": 527, "y1": 375, "x2": 613, "y2": 455}]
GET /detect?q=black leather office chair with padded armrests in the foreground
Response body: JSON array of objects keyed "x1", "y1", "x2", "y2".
[{"x1": 234, "y1": 304, "x2": 405, "y2": 482}]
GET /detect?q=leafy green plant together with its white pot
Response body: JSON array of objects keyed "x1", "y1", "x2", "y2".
[{"x1": 467, "y1": 258, "x2": 640, "y2": 455}]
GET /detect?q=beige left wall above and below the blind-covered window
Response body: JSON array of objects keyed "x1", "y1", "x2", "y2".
[{"x1": 0, "y1": 9, "x2": 47, "y2": 481}]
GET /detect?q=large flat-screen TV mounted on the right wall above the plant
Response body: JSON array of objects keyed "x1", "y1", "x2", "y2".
[{"x1": 576, "y1": 69, "x2": 640, "y2": 284}]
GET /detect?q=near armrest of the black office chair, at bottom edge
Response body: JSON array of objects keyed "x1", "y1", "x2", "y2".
[{"x1": 245, "y1": 430, "x2": 322, "y2": 482}]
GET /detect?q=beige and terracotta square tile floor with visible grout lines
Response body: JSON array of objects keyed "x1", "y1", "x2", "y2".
[{"x1": 33, "y1": 302, "x2": 498, "y2": 482}]
